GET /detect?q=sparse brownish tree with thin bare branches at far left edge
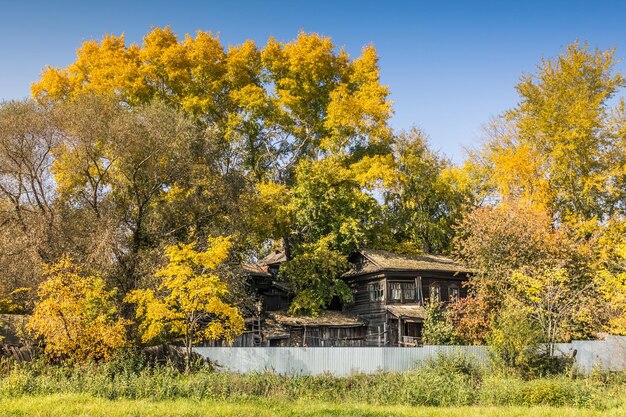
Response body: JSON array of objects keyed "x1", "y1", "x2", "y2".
[{"x1": 0, "y1": 101, "x2": 70, "y2": 311}]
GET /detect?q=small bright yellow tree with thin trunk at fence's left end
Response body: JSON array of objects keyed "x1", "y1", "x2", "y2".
[{"x1": 126, "y1": 237, "x2": 244, "y2": 370}]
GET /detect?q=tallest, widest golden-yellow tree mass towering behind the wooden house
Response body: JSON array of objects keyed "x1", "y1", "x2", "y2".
[{"x1": 32, "y1": 28, "x2": 393, "y2": 316}]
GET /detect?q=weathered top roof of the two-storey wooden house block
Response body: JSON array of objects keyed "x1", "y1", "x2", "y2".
[{"x1": 344, "y1": 249, "x2": 470, "y2": 276}]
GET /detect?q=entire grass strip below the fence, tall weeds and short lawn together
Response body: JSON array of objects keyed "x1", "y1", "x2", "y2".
[{"x1": 0, "y1": 356, "x2": 626, "y2": 417}]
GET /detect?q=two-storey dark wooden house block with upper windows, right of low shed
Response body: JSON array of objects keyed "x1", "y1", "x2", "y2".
[{"x1": 343, "y1": 249, "x2": 469, "y2": 346}]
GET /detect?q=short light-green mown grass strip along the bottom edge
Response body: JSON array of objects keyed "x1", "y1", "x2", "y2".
[{"x1": 0, "y1": 394, "x2": 626, "y2": 417}]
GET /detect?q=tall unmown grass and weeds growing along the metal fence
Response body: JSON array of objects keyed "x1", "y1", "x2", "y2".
[{"x1": 0, "y1": 355, "x2": 626, "y2": 408}]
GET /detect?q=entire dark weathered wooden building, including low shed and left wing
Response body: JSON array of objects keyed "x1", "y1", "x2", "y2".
[{"x1": 236, "y1": 249, "x2": 469, "y2": 347}]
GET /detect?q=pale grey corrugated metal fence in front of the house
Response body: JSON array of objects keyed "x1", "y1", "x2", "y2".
[{"x1": 194, "y1": 336, "x2": 626, "y2": 375}]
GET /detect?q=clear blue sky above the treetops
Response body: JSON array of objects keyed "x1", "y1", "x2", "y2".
[{"x1": 0, "y1": 0, "x2": 626, "y2": 161}]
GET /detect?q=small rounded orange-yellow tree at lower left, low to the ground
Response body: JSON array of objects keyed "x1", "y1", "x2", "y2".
[{"x1": 28, "y1": 257, "x2": 127, "y2": 362}]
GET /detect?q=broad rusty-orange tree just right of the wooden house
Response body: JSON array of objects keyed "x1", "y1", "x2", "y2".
[{"x1": 448, "y1": 203, "x2": 604, "y2": 343}]
